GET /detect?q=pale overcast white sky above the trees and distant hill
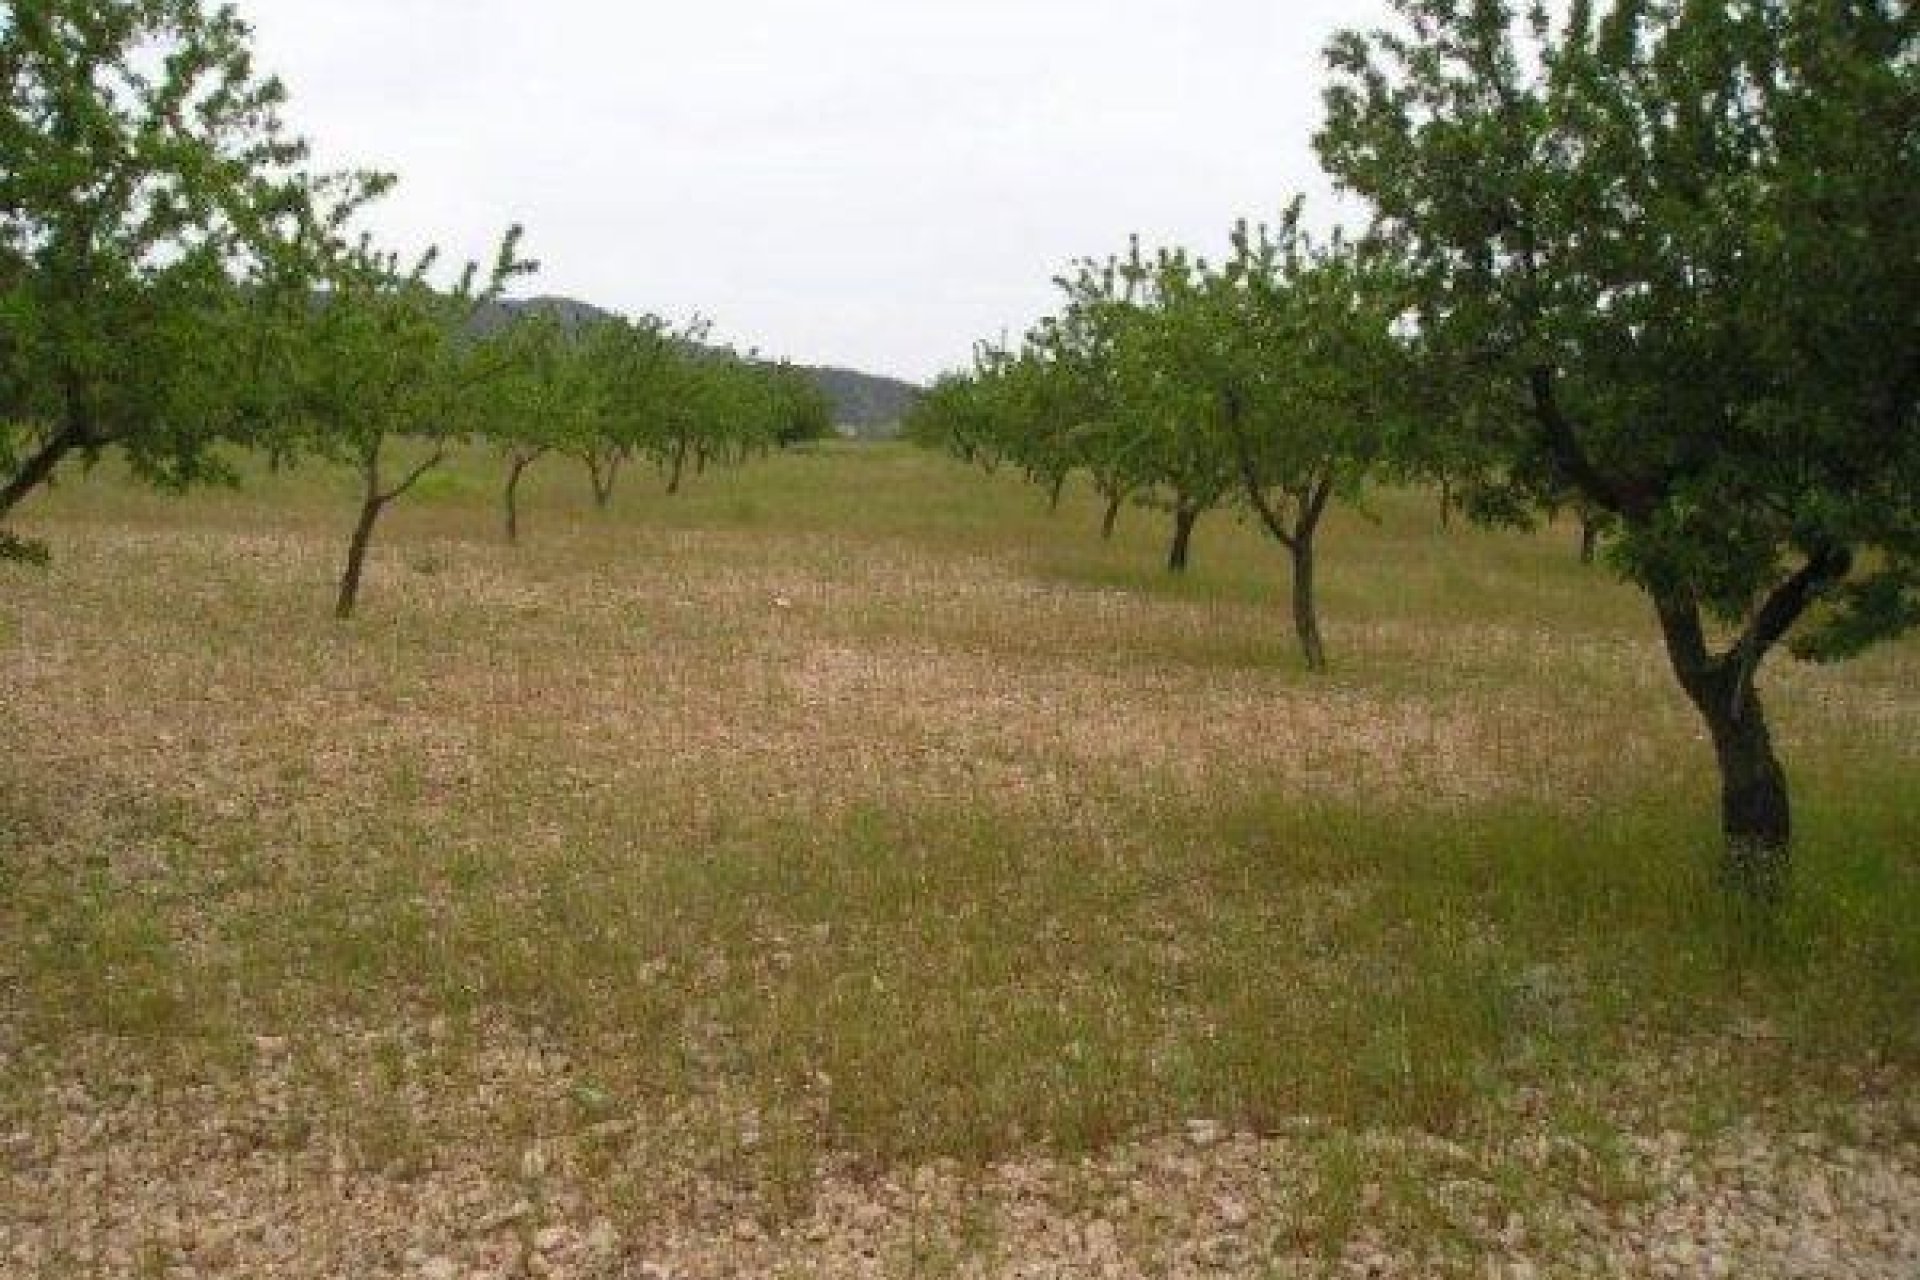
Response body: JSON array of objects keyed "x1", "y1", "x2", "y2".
[{"x1": 238, "y1": 0, "x2": 1384, "y2": 380}]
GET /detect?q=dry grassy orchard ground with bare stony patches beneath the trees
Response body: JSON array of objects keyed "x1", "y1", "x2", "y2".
[{"x1": 0, "y1": 447, "x2": 1920, "y2": 1276}]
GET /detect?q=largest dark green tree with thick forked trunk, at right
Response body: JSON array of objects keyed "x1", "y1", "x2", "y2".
[{"x1": 1319, "y1": 0, "x2": 1920, "y2": 902}]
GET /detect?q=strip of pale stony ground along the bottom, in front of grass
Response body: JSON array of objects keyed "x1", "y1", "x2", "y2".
[{"x1": 0, "y1": 1040, "x2": 1920, "y2": 1280}]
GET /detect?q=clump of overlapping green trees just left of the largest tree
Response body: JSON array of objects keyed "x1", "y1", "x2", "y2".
[{"x1": 908, "y1": 203, "x2": 1411, "y2": 668}]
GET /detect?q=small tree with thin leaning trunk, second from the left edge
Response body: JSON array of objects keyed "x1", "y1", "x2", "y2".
[{"x1": 298, "y1": 226, "x2": 534, "y2": 620}]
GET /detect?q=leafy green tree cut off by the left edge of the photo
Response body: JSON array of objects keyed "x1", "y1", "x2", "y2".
[{"x1": 0, "y1": 0, "x2": 386, "y2": 547}]
